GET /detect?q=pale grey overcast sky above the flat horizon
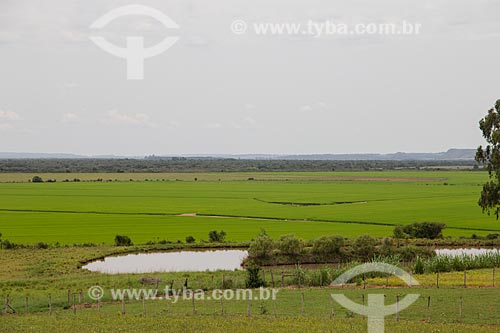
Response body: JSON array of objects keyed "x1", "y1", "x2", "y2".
[{"x1": 0, "y1": 0, "x2": 500, "y2": 155}]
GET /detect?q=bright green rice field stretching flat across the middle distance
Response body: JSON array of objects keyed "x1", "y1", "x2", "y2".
[{"x1": 0, "y1": 171, "x2": 494, "y2": 244}]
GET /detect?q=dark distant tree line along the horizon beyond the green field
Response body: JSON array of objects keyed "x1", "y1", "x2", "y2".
[{"x1": 0, "y1": 158, "x2": 477, "y2": 173}]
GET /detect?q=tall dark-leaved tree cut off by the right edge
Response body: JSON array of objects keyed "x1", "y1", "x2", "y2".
[{"x1": 476, "y1": 99, "x2": 500, "y2": 220}]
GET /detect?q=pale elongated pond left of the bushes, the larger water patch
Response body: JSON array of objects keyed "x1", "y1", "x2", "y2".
[{"x1": 82, "y1": 250, "x2": 248, "y2": 274}]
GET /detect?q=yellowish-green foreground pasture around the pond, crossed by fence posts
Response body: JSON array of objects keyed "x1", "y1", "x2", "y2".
[{"x1": 0, "y1": 247, "x2": 500, "y2": 326}]
